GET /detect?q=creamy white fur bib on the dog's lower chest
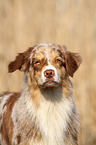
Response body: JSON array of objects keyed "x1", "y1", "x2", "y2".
[{"x1": 37, "y1": 96, "x2": 71, "y2": 145}]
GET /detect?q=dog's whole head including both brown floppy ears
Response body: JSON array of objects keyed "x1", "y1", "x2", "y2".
[{"x1": 8, "y1": 44, "x2": 81, "y2": 88}]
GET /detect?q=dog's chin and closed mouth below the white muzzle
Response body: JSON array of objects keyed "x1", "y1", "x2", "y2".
[{"x1": 40, "y1": 79, "x2": 60, "y2": 88}]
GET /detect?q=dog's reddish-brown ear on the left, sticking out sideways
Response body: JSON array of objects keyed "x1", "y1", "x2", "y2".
[{"x1": 8, "y1": 47, "x2": 33, "y2": 73}]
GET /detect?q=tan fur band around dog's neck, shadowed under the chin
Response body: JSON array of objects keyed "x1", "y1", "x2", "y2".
[{"x1": 24, "y1": 75, "x2": 73, "y2": 101}]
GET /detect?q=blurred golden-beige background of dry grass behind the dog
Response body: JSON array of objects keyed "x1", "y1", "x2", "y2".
[{"x1": 0, "y1": 0, "x2": 96, "y2": 145}]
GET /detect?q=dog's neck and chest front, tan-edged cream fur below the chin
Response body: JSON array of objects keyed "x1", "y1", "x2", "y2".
[{"x1": 20, "y1": 76, "x2": 74, "y2": 145}]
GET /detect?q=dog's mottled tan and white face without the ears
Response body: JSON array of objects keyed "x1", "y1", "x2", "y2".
[{"x1": 31, "y1": 45, "x2": 66, "y2": 88}]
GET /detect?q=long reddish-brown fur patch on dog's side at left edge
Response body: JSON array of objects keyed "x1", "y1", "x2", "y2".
[{"x1": 0, "y1": 93, "x2": 20, "y2": 145}]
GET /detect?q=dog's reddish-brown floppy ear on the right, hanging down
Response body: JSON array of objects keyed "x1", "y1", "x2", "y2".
[{"x1": 65, "y1": 51, "x2": 82, "y2": 77}]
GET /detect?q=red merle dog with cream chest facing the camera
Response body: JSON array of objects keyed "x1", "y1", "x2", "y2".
[{"x1": 0, "y1": 43, "x2": 82, "y2": 145}]
